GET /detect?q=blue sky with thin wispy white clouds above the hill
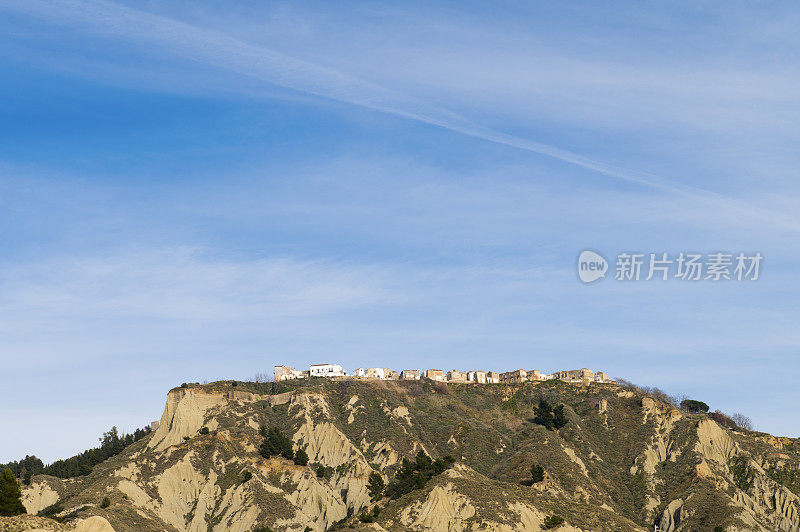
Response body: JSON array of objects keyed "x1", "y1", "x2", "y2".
[{"x1": 0, "y1": 0, "x2": 800, "y2": 461}]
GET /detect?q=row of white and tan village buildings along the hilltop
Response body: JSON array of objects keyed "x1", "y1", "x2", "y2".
[{"x1": 275, "y1": 364, "x2": 613, "y2": 384}]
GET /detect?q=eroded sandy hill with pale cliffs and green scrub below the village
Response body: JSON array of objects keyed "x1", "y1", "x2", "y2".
[{"x1": 17, "y1": 380, "x2": 800, "y2": 532}]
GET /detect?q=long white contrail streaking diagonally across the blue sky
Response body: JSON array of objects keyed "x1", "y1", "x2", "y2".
[{"x1": 6, "y1": 0, "x2": 800, "y2": 231}]
